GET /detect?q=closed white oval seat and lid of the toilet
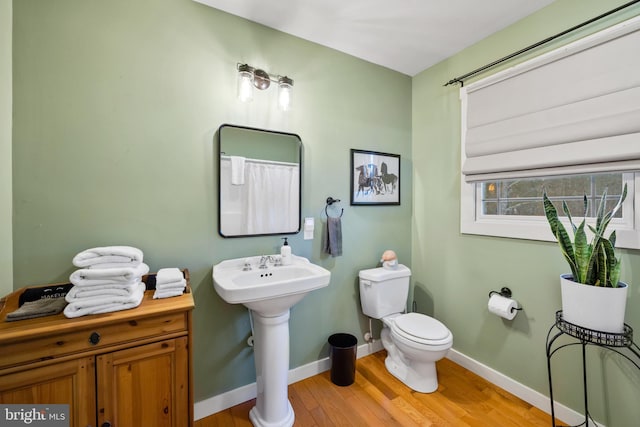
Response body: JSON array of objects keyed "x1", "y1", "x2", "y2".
[{"x1": 391, "y1": 313, "x2": 452, "y2": 346}]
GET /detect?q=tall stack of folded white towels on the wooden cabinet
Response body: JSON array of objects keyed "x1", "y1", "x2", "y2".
[{"x1": 64, "y1": 246, "x2": 149, "y2": 317}]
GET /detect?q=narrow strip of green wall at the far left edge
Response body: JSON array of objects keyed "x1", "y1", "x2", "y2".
[{"x1": 0, "y1": 0, "x2": 13, "y2": 295}]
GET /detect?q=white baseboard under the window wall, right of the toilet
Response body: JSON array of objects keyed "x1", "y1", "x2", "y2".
[{"x1": 447, "y1": 349, "x2": 605, "y2": 427}]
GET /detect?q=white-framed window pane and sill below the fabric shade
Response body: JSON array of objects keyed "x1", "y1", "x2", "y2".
[{"x1": 460, "y1": 173, "x2": 640, "y2": 249}]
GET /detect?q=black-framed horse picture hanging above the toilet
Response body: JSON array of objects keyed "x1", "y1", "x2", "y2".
[{"x1": 351, "y1": 148, "x2": 400, "y2": 205}]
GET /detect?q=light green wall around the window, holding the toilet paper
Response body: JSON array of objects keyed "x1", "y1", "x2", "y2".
[{"x1": 411, "y1": 0, "x2": 640, "y2": 427}]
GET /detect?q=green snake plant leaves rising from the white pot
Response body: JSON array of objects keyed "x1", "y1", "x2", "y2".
[{"x1": 543, "y1": 184, "x2": 627, "y2": 288}]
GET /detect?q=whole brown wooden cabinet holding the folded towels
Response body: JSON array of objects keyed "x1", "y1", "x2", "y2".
[{"x1": 0, "y1": 270, "x2": 194, "y2": 427}]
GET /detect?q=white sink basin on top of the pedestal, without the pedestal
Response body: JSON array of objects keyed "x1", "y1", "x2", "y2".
[{"x1": 213, "y1": 255, "x2": 331, "y2": 314}]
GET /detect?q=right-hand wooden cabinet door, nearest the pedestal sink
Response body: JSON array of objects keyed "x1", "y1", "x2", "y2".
[{"x1": 97, "y1": 337, "x2": 190, "y2": 427}]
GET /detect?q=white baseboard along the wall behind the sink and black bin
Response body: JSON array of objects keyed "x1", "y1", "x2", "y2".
[{"x1": 193, "y1": 340, "x2": 383, "y2": 421}]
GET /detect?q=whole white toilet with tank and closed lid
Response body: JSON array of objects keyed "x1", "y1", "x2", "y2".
[{"x1": 359, "y1": 264, "x2": 453, "y2": 393}]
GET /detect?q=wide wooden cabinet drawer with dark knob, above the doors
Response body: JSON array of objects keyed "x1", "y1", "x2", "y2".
[{"x1": 0, "y1": 313, "x2": 187, "y2": 369}]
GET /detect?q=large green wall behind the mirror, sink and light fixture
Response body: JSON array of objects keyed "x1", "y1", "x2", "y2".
[{"x1": 12, "y1": 0, "x2": 413, "y2": 401}]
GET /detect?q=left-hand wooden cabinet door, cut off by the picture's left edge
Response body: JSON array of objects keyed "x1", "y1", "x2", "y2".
[{"x1": 0, "y1": 357, "x2": 96, "y2": 427}]
